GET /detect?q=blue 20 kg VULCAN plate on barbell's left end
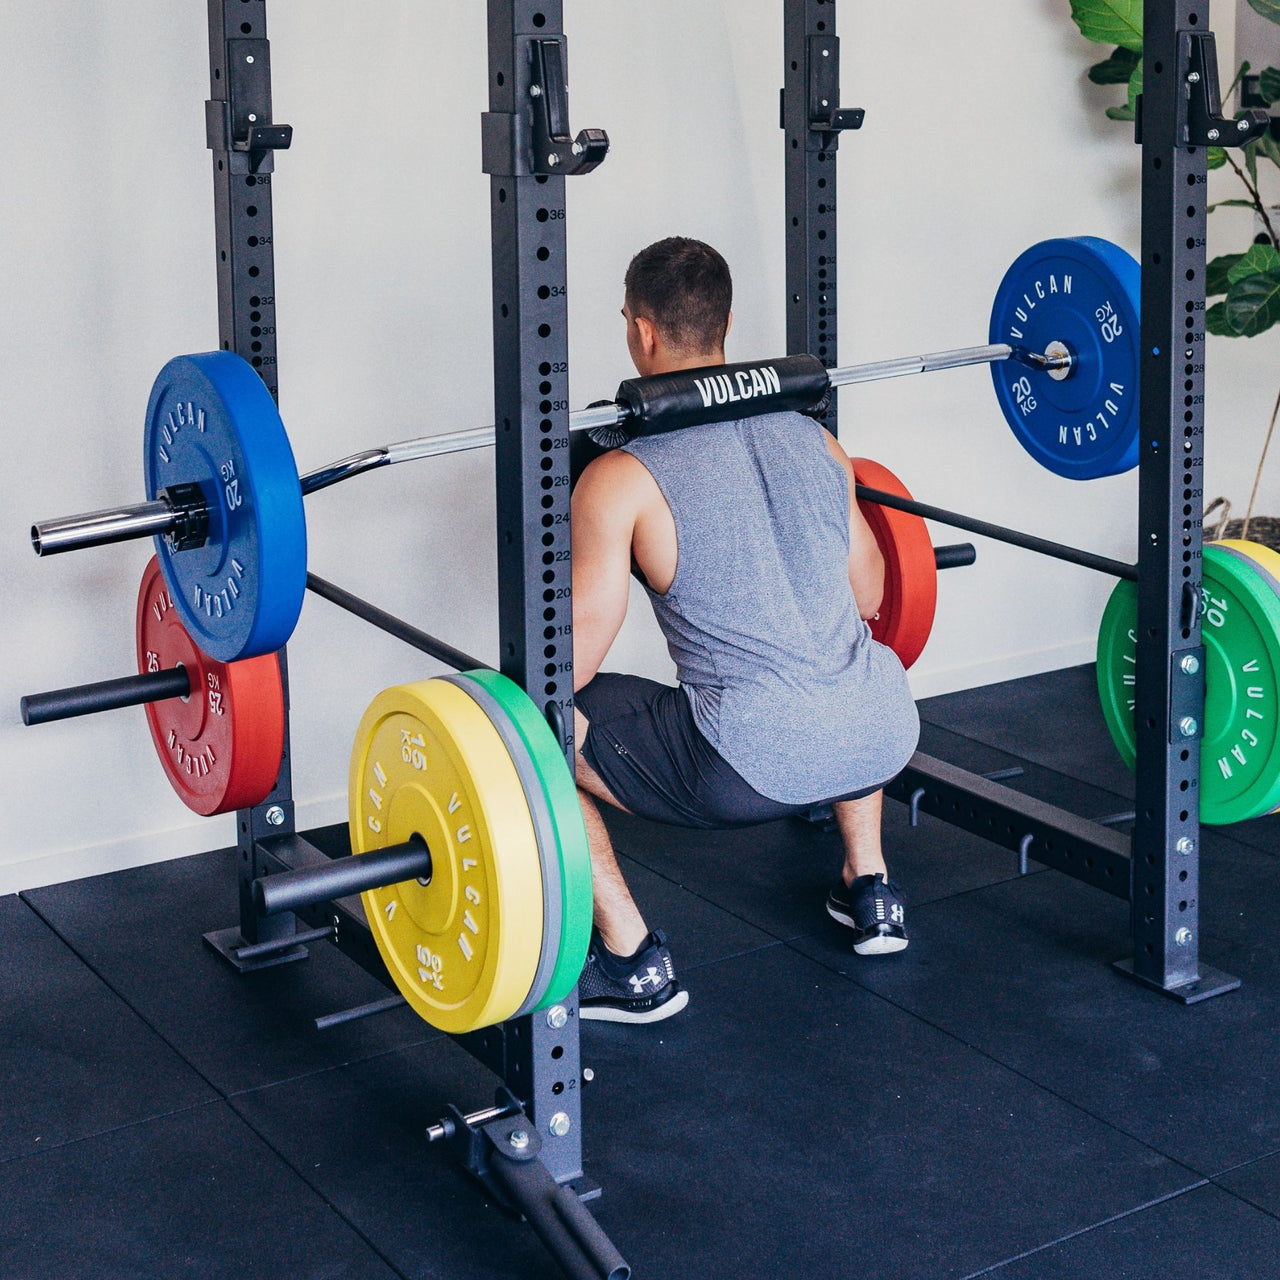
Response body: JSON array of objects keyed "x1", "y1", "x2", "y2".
[{"x1": 142, "y1": 351, "x2": 307, "y2": 662}]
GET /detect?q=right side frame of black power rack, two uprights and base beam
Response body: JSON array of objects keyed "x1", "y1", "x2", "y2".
[{"x1": 782, "y1": 0, "x2": 1266, "y2": 1004}]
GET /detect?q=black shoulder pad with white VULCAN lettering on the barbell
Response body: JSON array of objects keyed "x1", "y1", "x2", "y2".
[{"x1": 606, "y1": 355, "x2": 831, "y2": 440}]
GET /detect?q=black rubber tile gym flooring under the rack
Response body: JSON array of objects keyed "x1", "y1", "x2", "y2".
[{"x1": 0, "y1": 667, "x2": 1280, "y2": 1280}]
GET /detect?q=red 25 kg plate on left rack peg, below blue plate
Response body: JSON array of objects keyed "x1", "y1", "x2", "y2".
[{"x1": 137, "y1": 559, "x2": 284, "y2": 817}]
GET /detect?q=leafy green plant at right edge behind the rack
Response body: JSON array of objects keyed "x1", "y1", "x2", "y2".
[{"x1": 1070, "y1": 0, "x2": 1280, "y2": 550}]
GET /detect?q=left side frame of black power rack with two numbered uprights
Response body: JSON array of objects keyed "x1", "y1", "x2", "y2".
[{"x1": 195, "y1": 0, "x2": 630, "y2": 1280}]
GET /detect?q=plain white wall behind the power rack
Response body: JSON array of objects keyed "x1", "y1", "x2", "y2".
[{"x1": 0, "y1": 0, "x2": 1280, "y2": 891}]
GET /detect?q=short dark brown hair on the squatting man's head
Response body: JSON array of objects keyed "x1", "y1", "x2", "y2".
[{"x1": 625, "y1": 236, "x2": 733, "y2": 355}]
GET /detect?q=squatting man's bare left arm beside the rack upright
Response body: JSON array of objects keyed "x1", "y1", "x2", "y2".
[{"x1": 572, "y1": 452, "x2": 648, "y2": 692}]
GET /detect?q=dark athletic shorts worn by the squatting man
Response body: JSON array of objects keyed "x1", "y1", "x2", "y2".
[{"x1": 575, "y1": 672, "x2": 879, "y2": 828}]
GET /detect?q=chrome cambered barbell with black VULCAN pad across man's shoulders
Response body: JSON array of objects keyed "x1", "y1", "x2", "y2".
[{"x1": 31, "y1": 343, "x2": 1075, "y2": 556}]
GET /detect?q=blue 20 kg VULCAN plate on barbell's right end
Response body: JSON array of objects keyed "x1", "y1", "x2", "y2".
[{"x1": 989, "y1": 236, "x2": 1142, "y2": 480}]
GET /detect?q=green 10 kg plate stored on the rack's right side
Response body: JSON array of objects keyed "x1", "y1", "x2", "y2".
[{"x1": 1098, "y1": 543, "x2": 1280, "y2": 826}]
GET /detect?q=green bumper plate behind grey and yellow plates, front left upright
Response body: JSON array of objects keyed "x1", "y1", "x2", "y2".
[{"x1": 465, "y1": 671, "x2": 591, "y2": 1009}]
